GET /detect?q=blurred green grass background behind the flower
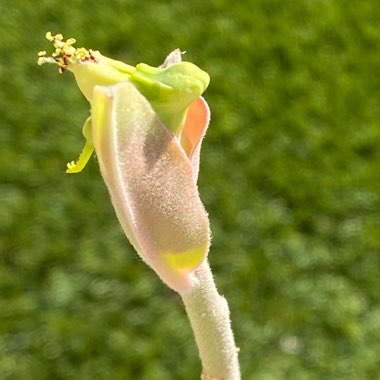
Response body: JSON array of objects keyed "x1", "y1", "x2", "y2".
[{"x1": 0, "y1": 0, "x2": 380, "y2": 380}]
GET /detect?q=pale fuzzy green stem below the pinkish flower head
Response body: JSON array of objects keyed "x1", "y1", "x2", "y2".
[{"x1": 181, "y1": 261, "x2": 240, "y2": 380}]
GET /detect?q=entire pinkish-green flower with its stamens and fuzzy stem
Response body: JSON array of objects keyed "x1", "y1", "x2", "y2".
[{"x1": 38, "y1": 33, "x2": 240, "y2": 380}]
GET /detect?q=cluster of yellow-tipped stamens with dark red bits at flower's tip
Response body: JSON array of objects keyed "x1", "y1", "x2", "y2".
[{"x1": 37, "y1": 32, "x2": 97, "y2": 74}]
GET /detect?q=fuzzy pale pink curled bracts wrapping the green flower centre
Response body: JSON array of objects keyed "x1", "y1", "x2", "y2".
[{"x1": 93, "y1": 82, "x2": 210, "y2": 292}]
